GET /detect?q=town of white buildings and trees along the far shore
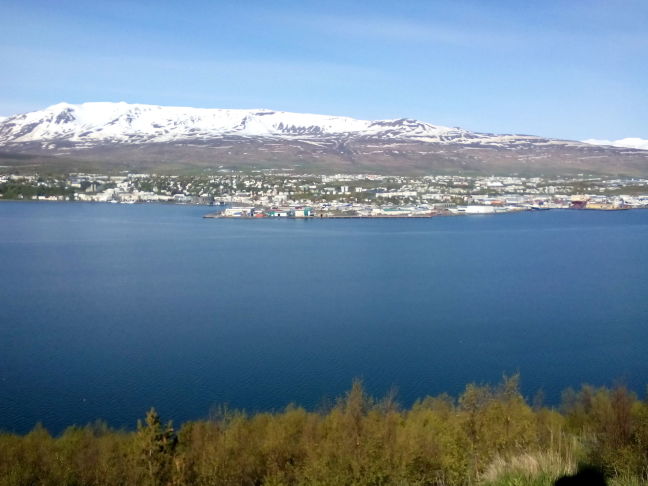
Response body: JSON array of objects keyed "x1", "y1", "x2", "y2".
[{"x1": 0, "y1": 169, "x2": 648, "y2": 218}]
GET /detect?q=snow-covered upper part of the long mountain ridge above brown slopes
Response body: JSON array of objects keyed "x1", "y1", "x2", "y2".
[{"x1": 0, "y1": 103, "x2": 572, "y2": 145}]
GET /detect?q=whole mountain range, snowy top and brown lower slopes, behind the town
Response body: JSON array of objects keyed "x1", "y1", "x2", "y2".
[{"x1": 0, "y1": 103, "x2": 648, "y2": 175}]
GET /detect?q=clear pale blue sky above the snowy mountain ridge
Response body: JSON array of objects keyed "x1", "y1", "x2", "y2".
[{"x1": 0, "y1": 0, "x2": 648, "y2": 139}]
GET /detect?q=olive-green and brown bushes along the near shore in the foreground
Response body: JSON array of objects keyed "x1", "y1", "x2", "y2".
[{"x1": 0, "y1": 375, "x2": 648, "y2": 486}]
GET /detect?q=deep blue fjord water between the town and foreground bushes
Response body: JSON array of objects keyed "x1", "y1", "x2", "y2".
[{"x1": 0, "y1": 202, "x2": 648, "y2": 432}]
